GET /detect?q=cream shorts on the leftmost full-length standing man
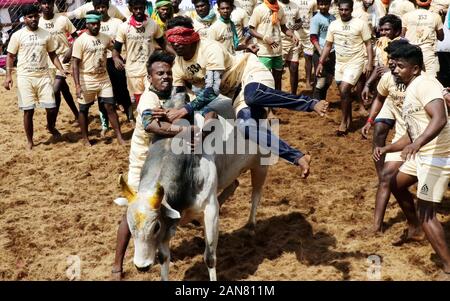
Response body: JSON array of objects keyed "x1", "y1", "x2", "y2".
[{"x1": 17, "y1": 75, "x2": 56, "y2": 111}]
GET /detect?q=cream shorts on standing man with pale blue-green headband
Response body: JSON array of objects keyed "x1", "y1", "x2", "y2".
[{"x1": 78, "y1": 78, "x2": 115, "y2": 105}]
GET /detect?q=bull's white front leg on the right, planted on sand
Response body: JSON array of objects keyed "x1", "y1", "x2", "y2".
[{"x1": 204, "y1": 193, "x2": 219, "y2": 281}]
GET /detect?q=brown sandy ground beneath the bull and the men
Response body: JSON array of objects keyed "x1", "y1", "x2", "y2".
[{"x1": 0, "y1": 63, "x2": 450, "y2": 280}]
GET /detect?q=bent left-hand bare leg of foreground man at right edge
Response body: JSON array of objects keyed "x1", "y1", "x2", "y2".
[{"x1": 391, "y1": 172, "x2": 424, "y2": 241}]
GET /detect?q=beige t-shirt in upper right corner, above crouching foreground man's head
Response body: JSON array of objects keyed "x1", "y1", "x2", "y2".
[{"x1": 402, "y1": 8, "x2": 443, "y2": 57}]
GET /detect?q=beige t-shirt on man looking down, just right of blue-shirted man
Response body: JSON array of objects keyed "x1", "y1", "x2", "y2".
[{"x1": 326, "y1": 18, "x2": 372, "y2": 63}]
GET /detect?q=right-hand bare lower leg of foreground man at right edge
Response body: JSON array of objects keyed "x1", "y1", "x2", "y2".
[{"x1": 417, "y1": 199, "x2": 450, "y2": 274}]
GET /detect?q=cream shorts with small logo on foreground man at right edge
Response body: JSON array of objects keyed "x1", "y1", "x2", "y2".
[{"x1": 400, "y1": 155, "x2": 450, "y2": 203}]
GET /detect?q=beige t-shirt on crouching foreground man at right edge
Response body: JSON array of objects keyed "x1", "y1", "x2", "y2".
[{"x1": 402, "y1": 75, "x2": 450, "y2": 157}]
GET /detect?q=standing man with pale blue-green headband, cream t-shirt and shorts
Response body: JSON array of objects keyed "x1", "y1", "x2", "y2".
[{"x1": 72, "y1": 10, "x2": 125, "y2": 146}]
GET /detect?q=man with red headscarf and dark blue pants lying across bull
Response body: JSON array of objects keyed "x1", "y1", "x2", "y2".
[{"x1": 166, "y1": 16, "x2": 328, "y2": 178}]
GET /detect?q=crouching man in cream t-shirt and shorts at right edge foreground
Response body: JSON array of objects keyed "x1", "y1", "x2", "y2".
[{"x1": 374, "y1": 44, "x2": 450, "y2": 280}]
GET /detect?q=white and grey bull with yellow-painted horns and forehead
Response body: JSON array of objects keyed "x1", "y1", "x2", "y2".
[{"x1": 115, "y1": 115, "x2": 268, "y2": 280}]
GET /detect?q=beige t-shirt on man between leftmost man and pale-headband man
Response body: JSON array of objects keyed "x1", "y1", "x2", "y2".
[{"x1": 39, "y1": 14, "x2": 77, "y2": 66}]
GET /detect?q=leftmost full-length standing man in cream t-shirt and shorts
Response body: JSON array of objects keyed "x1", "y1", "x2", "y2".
[{"x1": 3, "y1": 4, "x2": 65, "y2": 150}]
